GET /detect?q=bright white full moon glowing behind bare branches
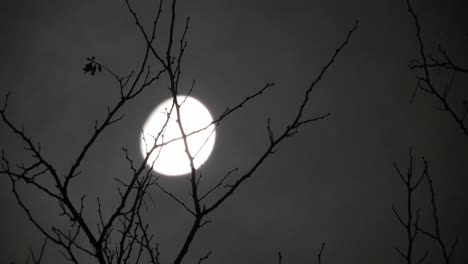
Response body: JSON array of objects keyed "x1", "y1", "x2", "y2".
[{"x1": 140, "y1": 95, "x2": 216, "y2": 176}]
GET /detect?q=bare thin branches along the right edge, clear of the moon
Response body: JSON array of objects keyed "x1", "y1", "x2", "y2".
[{"x1": 392, "y1": 0, "x2": 468, "y2": 264}]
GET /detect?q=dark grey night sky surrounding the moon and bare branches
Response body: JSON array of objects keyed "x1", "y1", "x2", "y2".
[{"x1": 0, "y1": 0, "x2": 468, "y2": 264}]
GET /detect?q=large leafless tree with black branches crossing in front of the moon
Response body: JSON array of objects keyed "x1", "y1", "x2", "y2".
[{"x1": 0, "y1": 0, "x2": 358, "y2": 264}]
